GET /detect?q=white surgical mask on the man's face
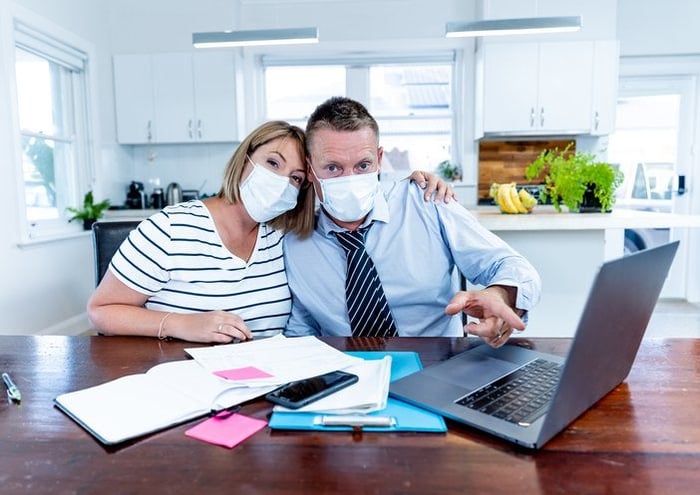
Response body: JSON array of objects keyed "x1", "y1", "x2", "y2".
[{"x1": 311, "y1": 168, "x2": 379, "y2": 222}]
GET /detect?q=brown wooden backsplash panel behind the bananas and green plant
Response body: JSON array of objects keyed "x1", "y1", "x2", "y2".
[{"x1": 479, "y1": 139, "x2": 576, "y2": 199}]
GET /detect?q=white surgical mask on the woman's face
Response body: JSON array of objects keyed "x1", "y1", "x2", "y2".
[{"x1": 239, "y1": 157, "x2": 299, "y2": 223}]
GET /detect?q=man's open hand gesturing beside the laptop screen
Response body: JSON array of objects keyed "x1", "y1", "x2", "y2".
[{"x1": 445, "y1": 286, "x2": 525, "y2": 348}]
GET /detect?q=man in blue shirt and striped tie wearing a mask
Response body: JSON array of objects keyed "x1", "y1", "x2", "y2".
[{"x1": 285, "y1": 97, "x2": 541, "y2": 347}]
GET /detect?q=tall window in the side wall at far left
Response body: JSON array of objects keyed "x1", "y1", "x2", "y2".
[{"x1": 15, "y1": 22, "x2": 90, "y2": 240}]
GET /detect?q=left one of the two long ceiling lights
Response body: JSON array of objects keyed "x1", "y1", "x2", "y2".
[{"x1": 192, "y1": 27, "x2": 318, "y2": 48}]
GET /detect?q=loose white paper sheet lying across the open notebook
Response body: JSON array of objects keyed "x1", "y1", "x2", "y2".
[{"x1": 185, "y1": 335, "x2": 363, "y2": 387}]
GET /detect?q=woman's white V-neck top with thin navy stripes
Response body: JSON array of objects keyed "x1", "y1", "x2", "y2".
[{"x1": 109, "y1": 200, "x2": 291, "y2": 337}]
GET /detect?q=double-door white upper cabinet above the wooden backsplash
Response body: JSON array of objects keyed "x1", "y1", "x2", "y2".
[{"x1": 484, "y1": 42, "x2": 593, "y2": 135}]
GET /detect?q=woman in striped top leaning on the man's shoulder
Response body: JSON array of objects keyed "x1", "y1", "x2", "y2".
[{"x1": 87, "y1": 121, "x2": 447, "y2": 343}]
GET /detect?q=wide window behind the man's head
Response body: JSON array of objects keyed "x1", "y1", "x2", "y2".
[{"x1": 263, "y1": 53, "x2": 455, "y2": 178}]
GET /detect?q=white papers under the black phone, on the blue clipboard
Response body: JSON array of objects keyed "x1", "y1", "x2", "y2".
[{"x1": 275, "y1": 356, "x2": 391, "y2": 414}]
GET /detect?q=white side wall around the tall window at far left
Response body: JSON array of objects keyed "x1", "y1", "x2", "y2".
[{"x1": 0, "y1": 0, "x2": 114, "y2": 334}]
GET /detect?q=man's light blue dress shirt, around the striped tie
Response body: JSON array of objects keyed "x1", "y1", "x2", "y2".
[{"x1": 284, "y1": 180, "x2": 541, "y2": 337}]
